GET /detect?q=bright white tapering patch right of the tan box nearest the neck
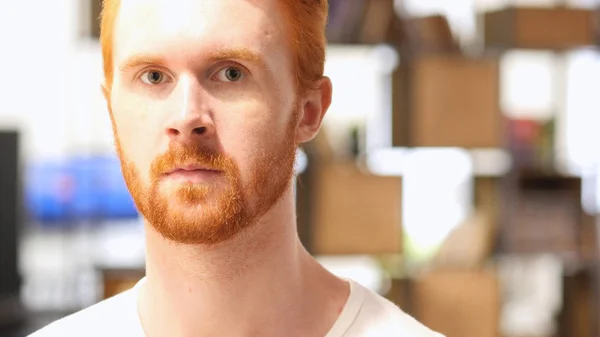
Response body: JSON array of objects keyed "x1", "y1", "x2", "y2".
[{"x1": 402, "y1": 149, "x2": 473, "y2": 259}]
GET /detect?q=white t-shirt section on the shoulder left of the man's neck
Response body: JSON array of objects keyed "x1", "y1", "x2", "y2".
[{"x1": 29, "y1": 290, "x2": 139, "y2": 337}]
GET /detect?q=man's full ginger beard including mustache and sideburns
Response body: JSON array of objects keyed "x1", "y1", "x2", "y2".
[{"x1": 111, "y1": 110, "x2": 298, "y2": 245}]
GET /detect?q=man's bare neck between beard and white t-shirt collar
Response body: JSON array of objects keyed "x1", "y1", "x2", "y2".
[{"x1": 139, "y1": 190, "x2": 348, "y2": 337}]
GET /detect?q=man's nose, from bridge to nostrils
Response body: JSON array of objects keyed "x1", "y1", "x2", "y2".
[{"x1": 165, "y1": 76, "x2": 215, "y2": 143}]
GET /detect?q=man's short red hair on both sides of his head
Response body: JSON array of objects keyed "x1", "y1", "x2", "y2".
[{"x1": 100, "y1": 0, "x2": 328, "y2": 92}]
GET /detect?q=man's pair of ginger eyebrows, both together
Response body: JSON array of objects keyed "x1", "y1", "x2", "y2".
[{"x1": 119, "y1": 48, "x2": 267, "y2": 72}]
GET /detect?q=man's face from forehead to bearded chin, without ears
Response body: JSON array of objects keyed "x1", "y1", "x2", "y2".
[{"x1": 108, "y1": 0, "x2": 299, "y2": 244}]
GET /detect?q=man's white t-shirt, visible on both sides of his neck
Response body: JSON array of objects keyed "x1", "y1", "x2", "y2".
[{"x1": 29, "y1": 280, "x2": 443, "y2": 337}]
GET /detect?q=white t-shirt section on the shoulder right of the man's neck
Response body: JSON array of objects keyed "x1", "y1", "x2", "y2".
[{"x1": 349, "y1": 282, "x2": 443, "y2": 337}]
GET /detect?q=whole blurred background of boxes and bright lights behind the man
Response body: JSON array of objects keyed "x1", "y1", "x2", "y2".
[{"x1": 0, "y1": 0, "x2": 600, "y2": 337}]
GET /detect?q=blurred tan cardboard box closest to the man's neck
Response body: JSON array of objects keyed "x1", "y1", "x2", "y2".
[{"x1": 310, "y1": 163, "x2": 402, "y2": 255}]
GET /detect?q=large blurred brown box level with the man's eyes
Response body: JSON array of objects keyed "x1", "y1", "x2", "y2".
[{"x1": 392, "y1": 55, "x2": 505, "y2": 148}]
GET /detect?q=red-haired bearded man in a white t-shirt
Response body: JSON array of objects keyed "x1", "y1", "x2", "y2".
[{"x1": 34, "y1": 0, "x2": 439, "y2": 337}]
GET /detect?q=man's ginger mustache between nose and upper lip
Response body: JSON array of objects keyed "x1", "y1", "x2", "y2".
[{"x1": 150, "y1": 145, "x2": 234, "y2": 179}]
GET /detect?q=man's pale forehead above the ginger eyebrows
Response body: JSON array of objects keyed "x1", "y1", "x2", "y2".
[{"x1": 113, "y1": 0, "x2": 285, "y2": 64}]
